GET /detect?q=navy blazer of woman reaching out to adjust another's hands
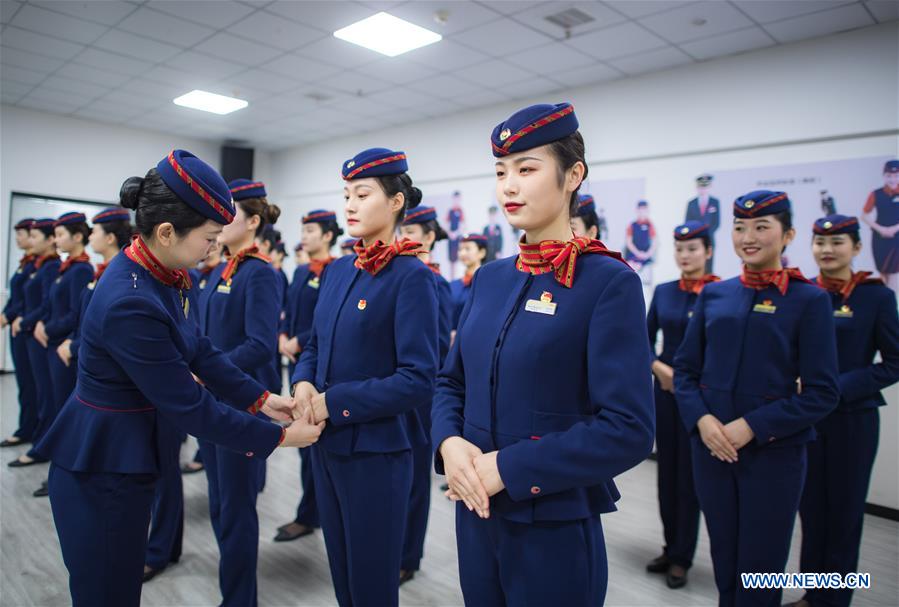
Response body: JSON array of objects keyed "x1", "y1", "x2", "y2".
[{"x1": 35, "y1": 255, "x2": 282, "y2": 474}]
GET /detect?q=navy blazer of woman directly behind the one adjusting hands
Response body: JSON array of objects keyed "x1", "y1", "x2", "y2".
[{"x1": 199, "y1": 257, "x2": 283, "y2": 398}]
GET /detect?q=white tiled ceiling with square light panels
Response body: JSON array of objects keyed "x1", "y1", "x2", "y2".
[{"x1": 0, "y1": 0, "x2": 899, "y2": 149}]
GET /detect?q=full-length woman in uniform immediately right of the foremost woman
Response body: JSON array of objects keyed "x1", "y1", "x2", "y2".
[{"x1": 646, "y1": 221, "x2": 720, "y2": 588}]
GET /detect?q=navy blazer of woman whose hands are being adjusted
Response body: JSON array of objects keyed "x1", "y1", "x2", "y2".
[{"x1": 291, "y1": 255, "x2": 438, "y2": 455}]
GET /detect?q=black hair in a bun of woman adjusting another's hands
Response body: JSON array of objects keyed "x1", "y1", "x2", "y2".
[{"x1": 119, "y1": 169, "x2": 206, "y2": 237}]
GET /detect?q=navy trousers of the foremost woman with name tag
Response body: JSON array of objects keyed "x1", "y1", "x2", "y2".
[{"x1": 456, "y1": 502, "x2": 608, "y2": 607}]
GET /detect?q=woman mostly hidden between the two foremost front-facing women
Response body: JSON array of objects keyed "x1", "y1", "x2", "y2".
[{"x1": 400, "y1": 206, "x2": 461, "y2": 585}]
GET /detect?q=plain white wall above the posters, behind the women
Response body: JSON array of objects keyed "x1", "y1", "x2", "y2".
[{"x1": 269, "y1": 23, "x2": 899, "y2": 508}]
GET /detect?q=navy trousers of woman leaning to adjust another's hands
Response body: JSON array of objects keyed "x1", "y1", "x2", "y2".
[{"x1": 49, "y1": 465, "x2": 156, "y2": 607}]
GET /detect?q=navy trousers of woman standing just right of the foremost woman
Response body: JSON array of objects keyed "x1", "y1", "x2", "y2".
[{"x1": 655, "y1": 383, "x2": 699, "y2": 569}]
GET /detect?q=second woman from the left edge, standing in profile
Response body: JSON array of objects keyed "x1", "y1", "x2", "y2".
[{"x1": 8, "y1": 218, "x2": 60, "y2": 468}]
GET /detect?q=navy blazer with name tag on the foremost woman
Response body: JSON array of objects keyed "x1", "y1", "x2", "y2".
[{"x1": 431, "y1": 255, "x2": 655, "y2": 522}]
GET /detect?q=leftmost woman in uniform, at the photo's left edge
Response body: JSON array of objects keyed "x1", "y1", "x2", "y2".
[{"x1": 0, "y1": 217, "x2": 37, "y2": 447}]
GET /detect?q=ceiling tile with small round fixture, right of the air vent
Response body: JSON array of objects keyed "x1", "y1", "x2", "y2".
[{"x1": 640, "y1": 2, "x2": 753, "y2": 44}]
